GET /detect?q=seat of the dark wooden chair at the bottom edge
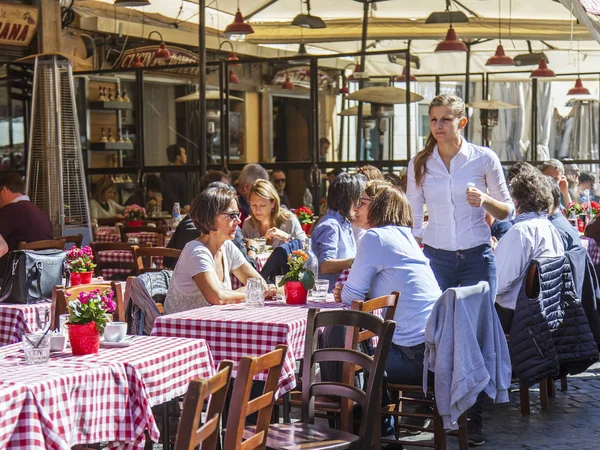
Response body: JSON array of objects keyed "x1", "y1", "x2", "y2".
[{"x1": 247, "y1": 422, "x2": 361, "y2": 450}]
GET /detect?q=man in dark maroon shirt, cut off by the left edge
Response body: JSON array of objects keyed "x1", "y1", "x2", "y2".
[{"x1": 0, "y1": 172, "x2": 53, "y2": 274}]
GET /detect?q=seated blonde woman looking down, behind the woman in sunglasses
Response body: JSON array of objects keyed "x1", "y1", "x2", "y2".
[{"x1": 242, "y1": 180, "x2": 306, "y2": 247}]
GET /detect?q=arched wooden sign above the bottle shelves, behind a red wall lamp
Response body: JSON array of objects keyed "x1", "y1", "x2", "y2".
[{"x1": 115, "y1": 45, "x2": 198, "y2": 76}]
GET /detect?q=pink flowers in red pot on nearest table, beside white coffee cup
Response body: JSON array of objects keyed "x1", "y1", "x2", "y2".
[{"x1": 67, "y1": 289, "x2": 117, "y2": 355}]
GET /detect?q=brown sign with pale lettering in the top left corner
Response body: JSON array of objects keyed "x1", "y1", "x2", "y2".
[{"x1": 0, "y1": 3, "x2": 38, "y2": 47}]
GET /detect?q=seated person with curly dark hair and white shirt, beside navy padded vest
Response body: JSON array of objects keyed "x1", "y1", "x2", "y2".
[{"x1": 495, "y1": 173, "x2": 564, "y2": 332}]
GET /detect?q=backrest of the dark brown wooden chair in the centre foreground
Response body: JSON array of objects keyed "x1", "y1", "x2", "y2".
[{"x1": 301, "y1": 308, "x2": 396, "y2": 442}]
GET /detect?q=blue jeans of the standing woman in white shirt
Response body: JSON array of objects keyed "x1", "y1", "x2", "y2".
[{"x1": 423, "y1": 244, "x2": 497, "y2": 299}]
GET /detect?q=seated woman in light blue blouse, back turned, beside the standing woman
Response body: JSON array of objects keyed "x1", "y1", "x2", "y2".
[{"x1": 334, "y1": 181, "x2": 442, "y2": 384}]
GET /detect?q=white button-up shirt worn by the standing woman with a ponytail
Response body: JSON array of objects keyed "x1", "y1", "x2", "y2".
[{"x1": 407, "y1": 138, "x2": 514, "y2": 251}]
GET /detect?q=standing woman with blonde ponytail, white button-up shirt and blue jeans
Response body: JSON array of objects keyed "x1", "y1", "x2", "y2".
[{"x1": 407, "y1": 94, "x2": 514, "y2": 293}]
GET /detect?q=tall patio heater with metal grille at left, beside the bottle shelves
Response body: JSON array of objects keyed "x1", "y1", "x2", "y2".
[{"x1": 26, "y1": 54, "x2": 92, "y2": 242}]
